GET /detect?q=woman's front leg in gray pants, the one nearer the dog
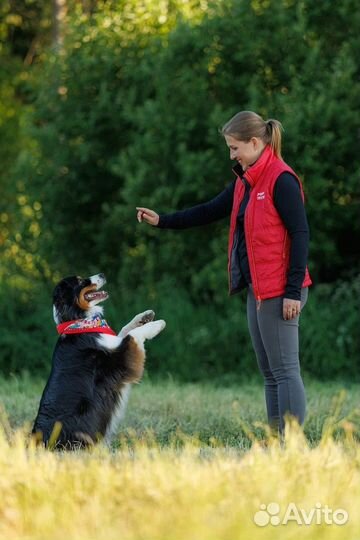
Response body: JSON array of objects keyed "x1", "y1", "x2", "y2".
[{"x1": 247, "y1": 286, "x2": 279, "y2": 429}]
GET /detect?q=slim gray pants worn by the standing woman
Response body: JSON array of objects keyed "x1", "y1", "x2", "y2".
[{"x1": 247, "y1": 286, "x2": 308, "y2": 433}]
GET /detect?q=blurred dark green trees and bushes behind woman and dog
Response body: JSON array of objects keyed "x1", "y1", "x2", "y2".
[{"x1": 0, "y1": 0, "x2": 360, "y2": 382}]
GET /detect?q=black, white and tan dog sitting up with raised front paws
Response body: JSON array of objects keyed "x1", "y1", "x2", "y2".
[{"x1": 32, "y1": 274, "x2": 165, "y2": 450}]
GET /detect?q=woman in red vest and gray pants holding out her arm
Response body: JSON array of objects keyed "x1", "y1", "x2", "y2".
[{"x1": 137, "y1": 111, "x2": 311, "y2": 433}]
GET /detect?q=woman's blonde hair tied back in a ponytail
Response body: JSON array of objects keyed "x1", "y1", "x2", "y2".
[{"x1": 220, "y1": 111, "x2": 283, "y2": 158}]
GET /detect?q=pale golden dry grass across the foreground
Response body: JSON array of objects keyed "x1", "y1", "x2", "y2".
[{"x1": 0, "y1": 424, "x2": 360, "y2": 540}]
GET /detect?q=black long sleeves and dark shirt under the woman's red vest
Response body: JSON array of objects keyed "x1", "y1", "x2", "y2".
[{"x1": 158, "y1": 173, "x2": 309, "y2": 300}]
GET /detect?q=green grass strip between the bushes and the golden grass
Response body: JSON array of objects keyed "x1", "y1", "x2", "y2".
[{"x1": 0, "y1": 376, "x2": 360, "y2": 450}]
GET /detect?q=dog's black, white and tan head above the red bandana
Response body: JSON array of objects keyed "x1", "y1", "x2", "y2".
[{"x1": 53, "y1": 274, "x2": 109, "y2": 324}]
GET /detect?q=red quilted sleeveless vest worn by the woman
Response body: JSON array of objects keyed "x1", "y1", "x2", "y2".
[{"x1": 228, "y1": 145, "x2": 312, "y2": 301}]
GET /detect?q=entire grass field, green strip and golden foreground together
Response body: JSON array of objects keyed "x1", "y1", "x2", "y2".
[{"x1": 0, "y1": 378, "x2": 360, "y2": 540}]
